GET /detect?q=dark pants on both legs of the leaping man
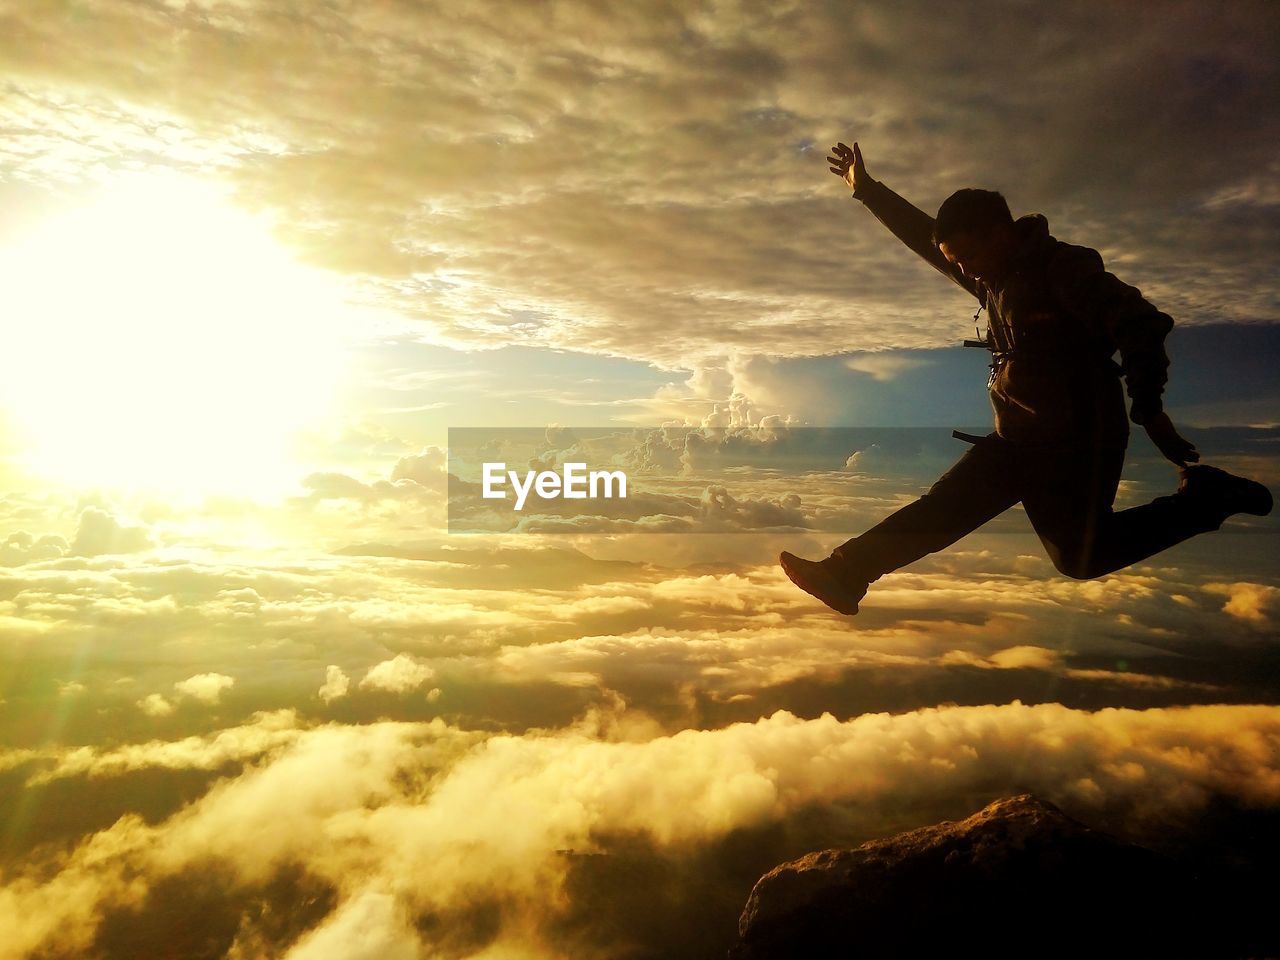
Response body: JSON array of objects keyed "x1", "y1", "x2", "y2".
[{"x1": 831, "y1": 434, "x2": 1225, "y2": 581}]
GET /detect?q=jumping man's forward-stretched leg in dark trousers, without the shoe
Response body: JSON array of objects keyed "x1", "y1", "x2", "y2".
[{"x1": 824, "y1": 434, "x2": 1021, "y2": 582}]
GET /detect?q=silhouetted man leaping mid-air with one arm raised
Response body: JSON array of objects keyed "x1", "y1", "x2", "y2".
[{"x1": 780, "y1": 143, "x2": 1272, "y2": 614}]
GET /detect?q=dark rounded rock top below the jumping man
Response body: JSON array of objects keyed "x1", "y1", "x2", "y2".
[{"x1": 730, "y1": 794, "x2": 1221, "y2": 960}]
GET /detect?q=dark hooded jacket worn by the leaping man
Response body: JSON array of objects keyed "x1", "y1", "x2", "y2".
[{"x1": 854, "y1": 180, "x2": 1174, "y2": 447}]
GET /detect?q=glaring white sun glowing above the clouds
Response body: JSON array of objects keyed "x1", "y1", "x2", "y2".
[{"x1": 0, "y1": 173, "x2": 353, "y2": 504}]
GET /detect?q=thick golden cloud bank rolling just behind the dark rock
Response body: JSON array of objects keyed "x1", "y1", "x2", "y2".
[{"x1": 0, "y1": 701, "x2": 1280, "y2": 957}]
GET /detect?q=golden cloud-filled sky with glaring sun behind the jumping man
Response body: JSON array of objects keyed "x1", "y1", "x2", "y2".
[{"x1": 0, "y1": 0, "x2": 1280, "y2": 960}]
